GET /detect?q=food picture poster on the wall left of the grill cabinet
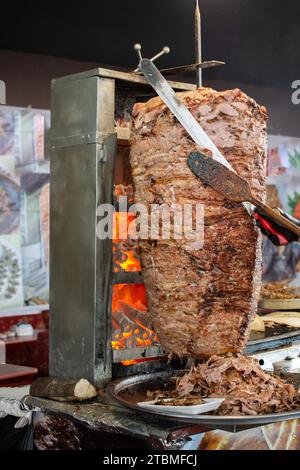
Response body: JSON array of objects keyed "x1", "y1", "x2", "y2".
[{"x1": 0, "y1": 106, "x2": 50, "y2": 314}]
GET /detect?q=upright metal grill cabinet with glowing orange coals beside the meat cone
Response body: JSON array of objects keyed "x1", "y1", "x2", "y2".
[{"x1": 50, "y1": 68, "x2": 195, "y2": 385}]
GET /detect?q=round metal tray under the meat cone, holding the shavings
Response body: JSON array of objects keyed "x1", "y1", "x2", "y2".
[{"x1": 107, "y1": 371, "x2": 300, "y2": 428}]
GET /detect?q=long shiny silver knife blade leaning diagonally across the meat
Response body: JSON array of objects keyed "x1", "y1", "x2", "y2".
[{"x1": 139, "y1": 59, "x2": 252, "y2": 215}]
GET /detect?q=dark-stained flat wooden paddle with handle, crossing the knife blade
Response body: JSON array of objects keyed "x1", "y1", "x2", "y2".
[{"x1": 188, "y1": 152, "x2": 300, "y2": 237}]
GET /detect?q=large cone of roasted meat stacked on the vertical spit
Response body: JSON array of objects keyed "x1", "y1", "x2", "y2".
[{"x1": 131, "y1": 88, "x2": 267, "y2": 358}]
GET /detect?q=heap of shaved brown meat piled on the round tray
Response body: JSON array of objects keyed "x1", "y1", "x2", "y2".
[{"x1": 153, "y1": 355, "x2": 300, "y2": 416}]
